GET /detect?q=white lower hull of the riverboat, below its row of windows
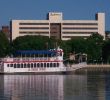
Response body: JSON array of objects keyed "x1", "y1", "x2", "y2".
[{"x1": 0, "y1": 63, "x2": 87, "y2": 74}]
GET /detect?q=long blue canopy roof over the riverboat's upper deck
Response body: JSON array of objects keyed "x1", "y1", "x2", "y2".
[{"x1": 15, "y1": 50, "x2": 56, "y2": 55}]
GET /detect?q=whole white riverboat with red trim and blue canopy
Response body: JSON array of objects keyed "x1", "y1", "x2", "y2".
[{"x1": 0, "y1": 47, "x2": 84, "y2": 74}]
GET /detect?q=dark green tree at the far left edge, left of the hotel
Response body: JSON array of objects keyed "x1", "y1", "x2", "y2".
[{"x1": 0, "y1": 32, "x2": 10, "y2": 57}]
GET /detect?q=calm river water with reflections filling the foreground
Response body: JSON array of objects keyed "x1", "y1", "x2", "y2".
[{"x1": 0, "y1": 74, "x2": 110, "y2": 100}]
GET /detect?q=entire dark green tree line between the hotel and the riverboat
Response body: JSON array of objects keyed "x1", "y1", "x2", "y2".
[{"x1": 0, "y1": 32, "x2": 110, "y2": 63}]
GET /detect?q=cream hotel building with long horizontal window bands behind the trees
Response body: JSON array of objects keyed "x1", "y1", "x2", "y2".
[{"x1": 11, "y1": 12, "x2": 105, "y2": 40}]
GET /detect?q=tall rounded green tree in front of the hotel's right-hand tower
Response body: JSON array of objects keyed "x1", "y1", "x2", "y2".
[{"x1": 86, "y1": 33, "x2": 103, "y2": 62}]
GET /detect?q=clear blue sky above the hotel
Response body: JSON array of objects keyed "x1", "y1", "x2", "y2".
[{"x1": 0, "y1": 0, "x2": 110, "y2": 31}]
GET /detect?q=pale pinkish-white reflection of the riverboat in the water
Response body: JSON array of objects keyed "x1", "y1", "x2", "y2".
[{"x1": 1, "y1": 75, "x2": 63, "y2": 100}]
